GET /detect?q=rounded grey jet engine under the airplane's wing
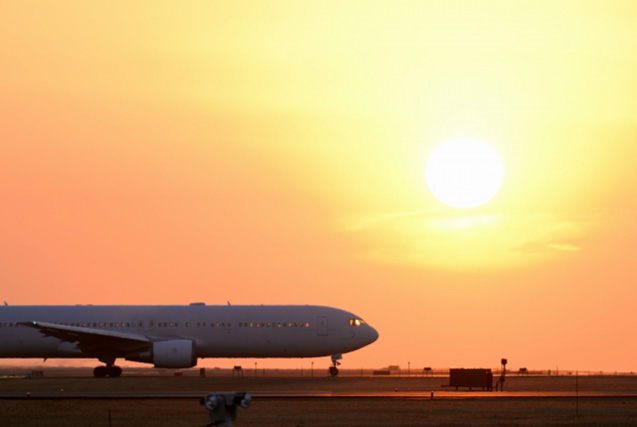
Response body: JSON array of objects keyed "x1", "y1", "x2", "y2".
[{"x1": 126, "y1": 340, "x2": 197, "y2": 369}]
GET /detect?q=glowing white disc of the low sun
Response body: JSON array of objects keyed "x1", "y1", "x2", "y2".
[{"x1": 425, "y1": 138, "x2": 504, "y2": 209}]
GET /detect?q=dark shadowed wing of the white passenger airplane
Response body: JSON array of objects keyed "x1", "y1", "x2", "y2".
[{"x1": 18, "y1": 322, "x2": 151, "y2": 354}]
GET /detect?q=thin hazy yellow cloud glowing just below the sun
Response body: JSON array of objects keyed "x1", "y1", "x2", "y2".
[{"x1": 349, "y1": 209, "x2": 595, "y2": 269}]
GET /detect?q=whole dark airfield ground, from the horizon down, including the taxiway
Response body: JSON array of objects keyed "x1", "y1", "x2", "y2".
[{"x1": 0, "y1": 372, "x2": 637, "y2": 427}]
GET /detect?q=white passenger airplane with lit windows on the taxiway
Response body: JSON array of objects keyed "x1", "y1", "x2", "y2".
[{"x1": 0, "y1": 302, "x2": 378, "y2": 378}]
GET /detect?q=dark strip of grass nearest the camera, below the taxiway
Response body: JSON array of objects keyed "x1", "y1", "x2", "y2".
[{"x1": 0, "y1": 398, "x2": 637, "y2": 426}]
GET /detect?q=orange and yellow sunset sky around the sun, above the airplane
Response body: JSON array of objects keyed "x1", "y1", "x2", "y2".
[{"x1": 0, "y1": 1, "x2": 637, "y2": 371}]
